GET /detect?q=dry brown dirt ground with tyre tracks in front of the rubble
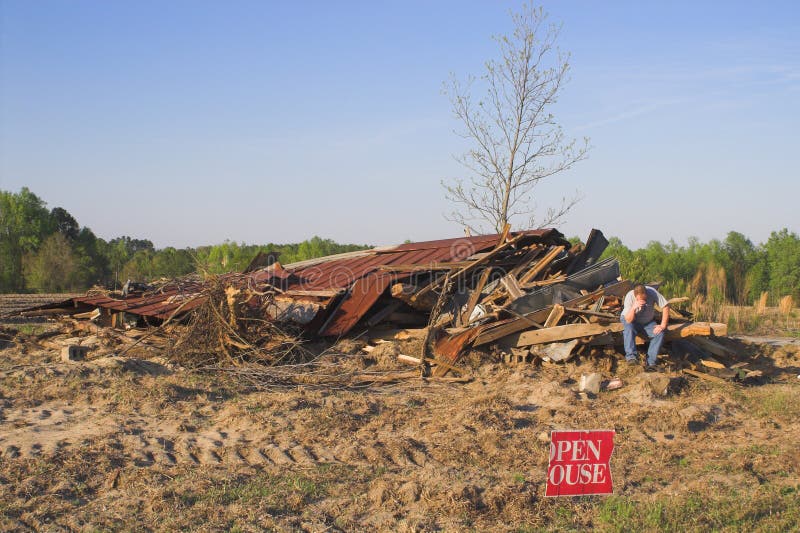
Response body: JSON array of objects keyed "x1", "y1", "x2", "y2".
[{"x1": 0, "y1": 322, "x2": 800, "y2": 531}]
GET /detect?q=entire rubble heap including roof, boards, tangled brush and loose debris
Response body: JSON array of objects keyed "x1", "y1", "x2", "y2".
[{"x1": 3, "y1": 229, "x2": 749, "y2": 384}]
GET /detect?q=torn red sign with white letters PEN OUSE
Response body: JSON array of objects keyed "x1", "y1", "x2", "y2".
[{"x1": 544, "y1": 430, "x2": 614, "y2": 496}]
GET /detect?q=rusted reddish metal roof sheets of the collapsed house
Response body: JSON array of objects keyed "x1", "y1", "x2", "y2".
[{"x1": 73, "y1": 229, "x2": 568, "y2": 335}]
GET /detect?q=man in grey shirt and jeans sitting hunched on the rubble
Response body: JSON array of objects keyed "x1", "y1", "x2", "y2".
[{"x1": 620, "y1": 284, "x2": 669, "y2": 372}]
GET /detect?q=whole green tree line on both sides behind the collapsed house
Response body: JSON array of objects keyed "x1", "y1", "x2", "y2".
[{"x1": 0, "y1": 188, "x2": 800, "y2": 305}]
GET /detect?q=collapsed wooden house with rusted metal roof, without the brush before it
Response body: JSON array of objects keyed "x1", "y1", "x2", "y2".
[{"x1": 14, "y1": 229, "x2": 733, "y2": 377}]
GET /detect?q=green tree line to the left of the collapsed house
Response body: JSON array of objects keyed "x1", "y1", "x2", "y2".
[{"x1": 0, "y1": 187, "x2": 369, "y2": 293}]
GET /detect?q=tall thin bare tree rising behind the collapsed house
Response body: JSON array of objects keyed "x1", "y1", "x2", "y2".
[{"x1": 442, "y1": 6, "x2": 589, "y2": 233}]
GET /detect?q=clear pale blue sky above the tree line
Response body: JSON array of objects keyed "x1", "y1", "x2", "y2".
[{"x1": 0, "y1": 0, "x2": 800, "y2": 248}]
